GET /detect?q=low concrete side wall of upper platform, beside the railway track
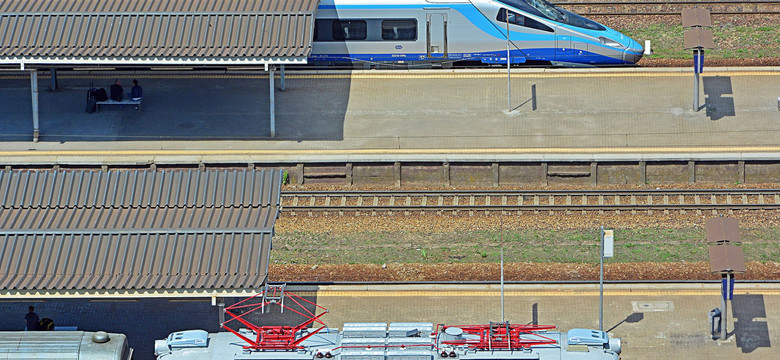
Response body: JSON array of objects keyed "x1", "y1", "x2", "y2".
[{"x1": 7, "y1": 160, "x2": 780, "y2": 187}]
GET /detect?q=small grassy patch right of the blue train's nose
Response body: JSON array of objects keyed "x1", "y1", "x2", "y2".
[{"x1": 617, "y1": 24, "x2": 780, "y2": 59}]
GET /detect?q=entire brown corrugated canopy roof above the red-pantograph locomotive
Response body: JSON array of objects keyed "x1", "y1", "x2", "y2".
[{"x1": 0, "y1": 169, "x2": 281, "y2": 297}]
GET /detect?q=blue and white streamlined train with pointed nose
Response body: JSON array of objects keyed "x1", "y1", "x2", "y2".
[{"x1": 309, "y1": 0, "x2": 643, "y2": 66}]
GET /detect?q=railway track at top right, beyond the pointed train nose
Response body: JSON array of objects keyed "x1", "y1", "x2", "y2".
[{"x1": 553, "y1": 0, "x2": 780, "y2": 16}]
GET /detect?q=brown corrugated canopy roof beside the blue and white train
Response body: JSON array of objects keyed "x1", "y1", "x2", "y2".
[{"x1": 0, "y1": 0, "x2": 319, "y2": 66}]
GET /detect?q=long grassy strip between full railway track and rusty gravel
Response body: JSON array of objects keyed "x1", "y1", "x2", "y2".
[{"x1": 273, "y1": 227, "x2": 780, "y2": 264}]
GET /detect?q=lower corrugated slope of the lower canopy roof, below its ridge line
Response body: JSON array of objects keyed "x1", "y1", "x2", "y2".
[{"x1": 0, "y1": 231, "x2": 271, "y2": 290}]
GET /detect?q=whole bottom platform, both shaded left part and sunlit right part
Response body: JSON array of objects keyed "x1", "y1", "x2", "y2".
[{"x1": 0, "y1": 281, "x2": 780, "y2": 360}]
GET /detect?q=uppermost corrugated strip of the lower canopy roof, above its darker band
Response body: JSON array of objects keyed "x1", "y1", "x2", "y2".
[{"x1": 0, "y1": 169, "x2": 282, "y2": 209}]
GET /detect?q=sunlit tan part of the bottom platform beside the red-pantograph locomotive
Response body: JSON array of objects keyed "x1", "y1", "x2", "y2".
[{"x1": 310, "y1": 284, "x2": 780, "y2": 360}]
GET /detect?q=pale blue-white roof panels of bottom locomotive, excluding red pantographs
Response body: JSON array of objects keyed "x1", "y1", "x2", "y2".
[{"x1": 155, "y1": 323, "x2": 619, "y2": 360}]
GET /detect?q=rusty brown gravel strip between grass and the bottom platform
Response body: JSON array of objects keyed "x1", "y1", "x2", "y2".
[{"x1": 269, "y1": 262, "x2": 780, "y2": 282}]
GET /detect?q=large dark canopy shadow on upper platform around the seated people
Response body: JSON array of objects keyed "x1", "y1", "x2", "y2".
[{"x1": 0, "y1": 74, "x2": 351, "y2": 142}]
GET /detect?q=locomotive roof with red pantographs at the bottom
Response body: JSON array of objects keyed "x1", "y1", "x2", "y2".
[{"x1": 155, "y1": 285, "x2": 621, "y2": 360}]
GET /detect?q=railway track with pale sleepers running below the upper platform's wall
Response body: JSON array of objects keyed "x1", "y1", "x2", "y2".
[{"x1": 282, "y1": 189, "x2": 780, "y2": 215}]
